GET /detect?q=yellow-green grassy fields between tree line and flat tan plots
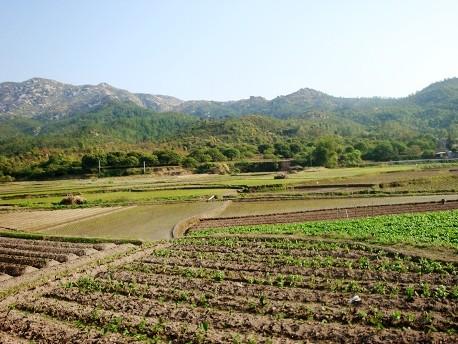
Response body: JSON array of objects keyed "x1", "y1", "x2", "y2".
[{"x1": 0, "y1": 165, "x2": 458, "y2": 208}]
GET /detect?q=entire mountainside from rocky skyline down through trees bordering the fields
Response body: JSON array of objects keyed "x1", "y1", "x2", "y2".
[{"x1": 0, "y1": 78, "x2": 458, "y2": 177}]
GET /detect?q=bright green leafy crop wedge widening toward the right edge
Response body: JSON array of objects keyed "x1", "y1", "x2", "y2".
[{"x1": 191, "y1": 211, "x2": 458, "y2": 249}]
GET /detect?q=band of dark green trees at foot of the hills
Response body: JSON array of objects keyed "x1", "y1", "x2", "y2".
[{"x1": 0, "y1": 135, "x2": 444, "y2": 180}]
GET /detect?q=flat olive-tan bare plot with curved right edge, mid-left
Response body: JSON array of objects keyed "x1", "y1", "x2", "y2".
[{"x1": 38, "y1": 202, "x2": 228, "y2": 240}]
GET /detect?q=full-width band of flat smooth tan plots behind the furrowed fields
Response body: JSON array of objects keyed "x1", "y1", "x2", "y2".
[{"x1": 0, "y1": 195, "x2": 458, "y2": 240}]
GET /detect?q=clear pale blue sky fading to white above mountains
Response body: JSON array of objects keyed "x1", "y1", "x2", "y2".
[{"x1": 0, "y1": 0, "x2": 458, "y2": 100}]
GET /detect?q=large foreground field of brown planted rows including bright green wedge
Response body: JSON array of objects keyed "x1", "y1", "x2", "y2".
[{"x1": 0, "y1": 211, "x2": 458, "y2": 343}]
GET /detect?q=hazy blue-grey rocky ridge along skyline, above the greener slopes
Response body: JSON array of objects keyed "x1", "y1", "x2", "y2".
[{"x1": 0, "y1": 78, "x2": 458, "y2": 118}]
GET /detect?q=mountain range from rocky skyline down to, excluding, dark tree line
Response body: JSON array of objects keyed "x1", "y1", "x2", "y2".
[{"x1": 0, "y1": 78, "x2": 458, "y2": 154}]
